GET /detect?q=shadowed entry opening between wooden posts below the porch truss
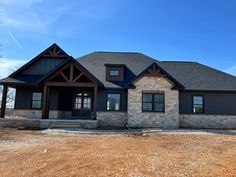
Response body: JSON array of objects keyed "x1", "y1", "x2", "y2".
[{"x1": 39, "y1": 86, "x2": 97, "y2": 120}]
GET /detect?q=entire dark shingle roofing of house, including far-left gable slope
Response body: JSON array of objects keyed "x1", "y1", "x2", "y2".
[{"x1": 0, "y1": 44, "x2": 236, "y2": 92}]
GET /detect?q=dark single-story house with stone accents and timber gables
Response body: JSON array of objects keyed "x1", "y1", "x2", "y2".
[{"x1": 0, "y1": 44, "x2": 236, "y2": 129}]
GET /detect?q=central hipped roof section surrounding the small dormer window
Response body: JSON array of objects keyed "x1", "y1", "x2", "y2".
[{"x1": 77, "y1": 52, "x2": 156, "y2": 88}]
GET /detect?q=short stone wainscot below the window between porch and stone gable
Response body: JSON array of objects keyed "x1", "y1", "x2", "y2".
[{"x1": 97, "y1": 111, "x2": 127, "y2": 127}]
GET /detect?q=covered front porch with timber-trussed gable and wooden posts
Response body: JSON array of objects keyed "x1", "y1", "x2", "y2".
[{"x1": 0, "y1": 59, "x2": 103, "y2": 120}]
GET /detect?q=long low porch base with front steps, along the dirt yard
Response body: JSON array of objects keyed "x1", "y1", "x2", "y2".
[{"x1": 0, "y1": 118, "x2": 98, "y2": 129}]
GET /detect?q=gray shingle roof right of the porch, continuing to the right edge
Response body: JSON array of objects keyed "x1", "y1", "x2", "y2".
[{"x1": 77, "y1": 52, "x2": 236, "y2": 91}]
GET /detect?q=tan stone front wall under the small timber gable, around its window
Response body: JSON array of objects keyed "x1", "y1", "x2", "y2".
[{"x1": 128, "y1": 76, "x2": 179, "y2": 128}]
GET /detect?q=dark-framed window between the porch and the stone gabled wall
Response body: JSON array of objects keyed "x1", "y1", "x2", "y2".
[{"x1": 107, "y1": 93, "x2": 120, "y2": 111}]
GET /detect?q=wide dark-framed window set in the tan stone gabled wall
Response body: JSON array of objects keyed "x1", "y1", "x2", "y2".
[{"x1": 142, "y1": 93, "x2": 165, "y2": 112}]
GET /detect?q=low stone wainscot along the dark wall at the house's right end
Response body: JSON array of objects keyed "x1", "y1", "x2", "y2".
[{"x1": 179, "y1": 114, "x2": 236, "y2": 129}]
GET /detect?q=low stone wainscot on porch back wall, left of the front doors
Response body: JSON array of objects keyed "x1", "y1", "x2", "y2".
[{"x1": 13, "y1": 109, "x2": 71, "y2": 119}]
